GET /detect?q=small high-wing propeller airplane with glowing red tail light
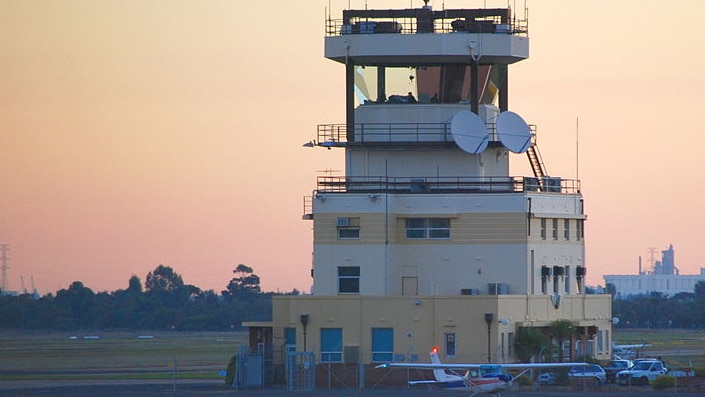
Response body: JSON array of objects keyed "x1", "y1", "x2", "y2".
[{"x1": 376, "y1": 347, "x2": 585, "y2": 397}]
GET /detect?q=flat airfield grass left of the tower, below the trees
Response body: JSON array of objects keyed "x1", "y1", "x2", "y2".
[{"x1": 0, "y1": 332, "x2": 247, "y2": 380}]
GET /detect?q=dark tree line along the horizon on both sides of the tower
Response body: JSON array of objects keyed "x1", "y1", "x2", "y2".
[{"x1": 0, "y1": 270, "x2": 705, "y2": 331}]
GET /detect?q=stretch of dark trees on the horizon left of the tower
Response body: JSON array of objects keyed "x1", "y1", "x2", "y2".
[{"x1": 0, "y1": 264, "x2": 299, "y2": 331}]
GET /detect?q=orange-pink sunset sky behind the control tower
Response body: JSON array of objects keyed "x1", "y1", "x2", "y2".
[{"x1": 0, "y1": 0, "x2": 705, "y2": 294}]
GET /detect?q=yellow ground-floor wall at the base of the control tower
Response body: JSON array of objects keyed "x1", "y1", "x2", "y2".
[{"x1": 273, "y1": 295, "x2": 612, "y2": 363}]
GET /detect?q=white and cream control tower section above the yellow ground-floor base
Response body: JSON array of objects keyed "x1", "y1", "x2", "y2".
[{"x1": 304, "y1": 6, "x2": 585, "y2": 295}]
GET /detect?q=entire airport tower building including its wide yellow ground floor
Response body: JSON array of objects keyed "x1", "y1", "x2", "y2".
[{"x1": 246, "y1": 1, "x2": 611, "y2": 385}]
